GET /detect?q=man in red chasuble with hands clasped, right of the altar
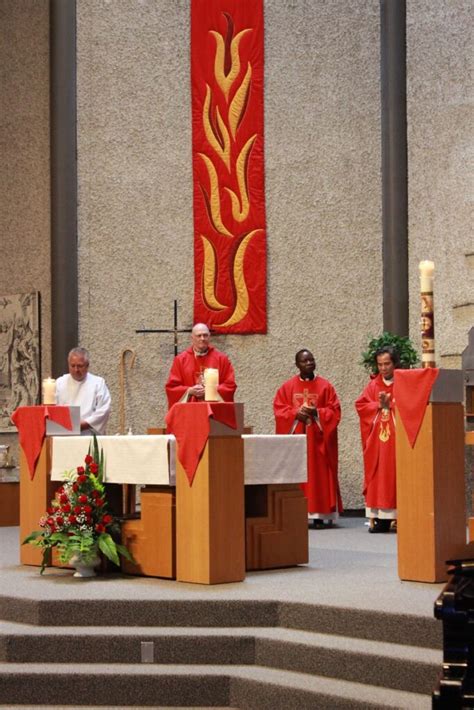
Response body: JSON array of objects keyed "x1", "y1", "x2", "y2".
[{"x1": 273, "y1": 350, "x2": 342, "y2": 528}]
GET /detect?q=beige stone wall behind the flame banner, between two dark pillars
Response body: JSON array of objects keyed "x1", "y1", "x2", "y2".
[{"x1": 78, "y1": 0, "x2": 382, "y2": 507}]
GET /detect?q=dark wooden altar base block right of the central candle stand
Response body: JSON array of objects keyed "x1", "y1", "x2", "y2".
[{"x1": 245, "y1": 483, "x2": 309, "y2": 570}]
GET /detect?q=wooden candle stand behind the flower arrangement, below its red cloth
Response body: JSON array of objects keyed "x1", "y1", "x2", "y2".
[{"x1": 20, "y1": 439, "x2": 59, "y2": 566}]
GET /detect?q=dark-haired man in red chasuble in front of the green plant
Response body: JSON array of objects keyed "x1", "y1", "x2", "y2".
[{"x1": 355, "y1": 345, "x2": 400, "y2": 533}]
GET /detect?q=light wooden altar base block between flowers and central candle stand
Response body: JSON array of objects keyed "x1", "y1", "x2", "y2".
[{"x1": 121, "y1": 486, "x2": 176, "y2": 579}]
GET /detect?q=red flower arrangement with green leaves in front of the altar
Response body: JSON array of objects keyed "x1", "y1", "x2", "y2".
[{"x1": 22, "y1": 436, "x2": 134, "y2": 574}]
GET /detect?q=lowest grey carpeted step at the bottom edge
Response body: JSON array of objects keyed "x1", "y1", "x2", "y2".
[{"x1": 0, "y1": 663, "x2": 431, "y2": 710}]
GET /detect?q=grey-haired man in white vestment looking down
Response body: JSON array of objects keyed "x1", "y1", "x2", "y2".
[{"x1": 56, "y1": 348, "x2": 112, "y2": 435}]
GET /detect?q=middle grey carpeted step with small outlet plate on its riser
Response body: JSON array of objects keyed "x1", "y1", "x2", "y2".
[{"x1": 0, "y1": 623, "x2": 442, "y2": 693}]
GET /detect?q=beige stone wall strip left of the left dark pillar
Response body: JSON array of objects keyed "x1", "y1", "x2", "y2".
[{"x1": 0, "y1": 0, "x2": 51, "y2": 461}]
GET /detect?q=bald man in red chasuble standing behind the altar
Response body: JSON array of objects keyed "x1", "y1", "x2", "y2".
[{"x1": 166, "y1": 323, "x2": 237, "y2": 409}]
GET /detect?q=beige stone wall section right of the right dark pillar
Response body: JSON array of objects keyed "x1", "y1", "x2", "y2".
[{"x1": 407, "y1": 0, "x2": 474, "y2": 368}]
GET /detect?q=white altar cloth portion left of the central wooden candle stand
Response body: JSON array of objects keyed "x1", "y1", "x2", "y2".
[{"x1": 51, "y1": 435, "x2": 176, "y2": 486}]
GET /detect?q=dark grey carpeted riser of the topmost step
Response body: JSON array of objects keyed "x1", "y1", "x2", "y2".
[{"x1": 0, "y1": 596, "x2": 442, "y2": 648}]
